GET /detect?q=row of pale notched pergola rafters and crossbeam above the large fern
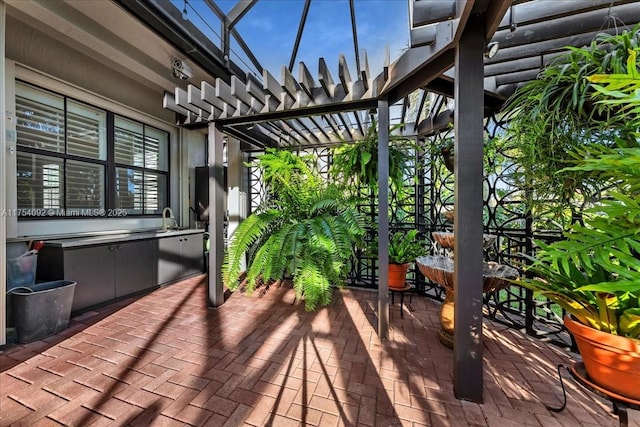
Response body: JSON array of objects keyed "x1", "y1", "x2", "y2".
[{"x1": 163, "y1": 50, "x2": 388, "y2": 147}]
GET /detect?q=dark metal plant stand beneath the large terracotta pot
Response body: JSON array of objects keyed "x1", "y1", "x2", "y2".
[{"x1": 547, "y1": 362, "x2": 640, "y2": 427}]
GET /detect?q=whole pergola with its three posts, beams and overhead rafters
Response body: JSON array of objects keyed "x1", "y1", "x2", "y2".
[{"x1": 118, "y1": 0, "x2": 640, "y2": 401}]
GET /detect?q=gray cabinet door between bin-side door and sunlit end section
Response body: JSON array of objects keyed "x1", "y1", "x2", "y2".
[{"x1": 114, "y1": 240, "x2": 155, "y2": 298}]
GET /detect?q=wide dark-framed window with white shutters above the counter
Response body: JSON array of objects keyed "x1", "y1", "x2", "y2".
[{"x1": 16, "y1": 82, "x2": 169, "y2": 217}]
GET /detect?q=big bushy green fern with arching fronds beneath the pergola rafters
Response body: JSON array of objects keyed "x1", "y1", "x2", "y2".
[{"x1": 223, "y1": 150, "x2": 364, "y2": 311}]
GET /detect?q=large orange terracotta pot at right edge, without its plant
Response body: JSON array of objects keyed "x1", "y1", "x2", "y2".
[{"x1": 564, "y1": 317, "x2": 640, "y2": 400}]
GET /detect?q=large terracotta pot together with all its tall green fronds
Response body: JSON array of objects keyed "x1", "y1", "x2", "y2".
[{"x1": 516, "y1": 60, "x2": 640, "y2": 400}]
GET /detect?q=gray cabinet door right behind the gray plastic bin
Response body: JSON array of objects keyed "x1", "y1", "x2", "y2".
[{"x1": 64, "y1": 245, "x2": 116, "y2": 311}]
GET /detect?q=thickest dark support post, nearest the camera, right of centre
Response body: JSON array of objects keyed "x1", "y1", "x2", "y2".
[{"x1": 453, "y1": 16, "x2": 485, "y2": 402}]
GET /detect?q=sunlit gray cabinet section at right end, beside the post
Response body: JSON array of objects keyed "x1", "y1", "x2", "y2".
[{"x1": 158, "y1": 233, "x2": 204, "y2": 284}]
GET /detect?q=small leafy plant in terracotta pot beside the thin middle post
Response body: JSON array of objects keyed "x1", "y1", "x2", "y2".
[{"x1": 387, "y1": 230, "x2": 427, "y2": 289}]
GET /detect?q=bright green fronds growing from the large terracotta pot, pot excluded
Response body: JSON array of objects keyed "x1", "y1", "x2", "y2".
[{"x1": 519, "y1": 54, "x2": 640, "y2": 339}]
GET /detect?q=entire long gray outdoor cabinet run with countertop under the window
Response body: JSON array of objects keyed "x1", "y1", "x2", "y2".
[{"x1": 37, "y1": 230, "x2": 204, "y2": 311}]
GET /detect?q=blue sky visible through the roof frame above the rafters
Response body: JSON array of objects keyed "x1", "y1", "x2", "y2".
[{"x1": 178, "y1": 0, "x2": 409, "y2": 80}]
